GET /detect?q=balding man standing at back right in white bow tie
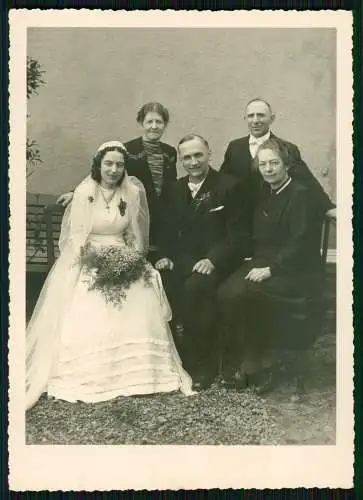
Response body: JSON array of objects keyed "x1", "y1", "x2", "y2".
[{"x1": 221, "y1": 98, "x2": 335, "y2": 229}]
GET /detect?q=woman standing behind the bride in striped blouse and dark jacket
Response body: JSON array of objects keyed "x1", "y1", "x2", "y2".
[{"x1": 57, "y1": 102, "x2": 177, "y2": 262}]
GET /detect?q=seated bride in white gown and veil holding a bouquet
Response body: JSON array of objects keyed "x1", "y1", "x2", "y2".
[{"x1": 26, "y1": 141, "x2": 193, "y2": 409}]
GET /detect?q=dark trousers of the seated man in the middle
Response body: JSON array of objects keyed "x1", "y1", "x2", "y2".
[{"x1": 161, "y1": 266, "x2": 220, "y2": 373}]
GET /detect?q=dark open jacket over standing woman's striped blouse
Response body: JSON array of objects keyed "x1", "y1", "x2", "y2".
[{"x1": 124, "y1": 137, "x2": 177, "y2": 245}]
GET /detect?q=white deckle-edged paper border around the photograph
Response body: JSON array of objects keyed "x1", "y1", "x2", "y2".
[{"x1": 9, "y1": 9, "x2": 354, "y2": 491}]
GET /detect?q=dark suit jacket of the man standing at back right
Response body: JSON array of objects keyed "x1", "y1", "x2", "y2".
[{"x1": 221, "y1": 133, "x2": 334, "y2": 224}]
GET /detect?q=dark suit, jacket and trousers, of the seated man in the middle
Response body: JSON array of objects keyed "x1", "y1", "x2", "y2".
[{"x1": 162, "y1": 169, "x2": 248, "y2": 373}]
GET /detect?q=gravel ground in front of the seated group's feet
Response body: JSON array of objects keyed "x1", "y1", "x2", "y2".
[{"x1": 26, "y1": 335, "x2": 335, "y2": 445}]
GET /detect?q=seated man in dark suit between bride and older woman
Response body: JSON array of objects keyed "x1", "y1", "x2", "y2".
[{"x1": 155, "y1": 134, "x2": 248, "y2": 388}]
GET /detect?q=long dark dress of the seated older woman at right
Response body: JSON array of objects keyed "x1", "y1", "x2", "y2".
[{"x1": 218, "y1": 179, "x2": 322, "y2": 364}]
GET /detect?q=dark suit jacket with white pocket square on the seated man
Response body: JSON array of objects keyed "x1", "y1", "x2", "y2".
[{"x1": 162, "y1": 169, "x2": 248, "y2": 275}]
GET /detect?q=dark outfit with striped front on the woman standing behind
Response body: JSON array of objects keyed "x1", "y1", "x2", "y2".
[{"x1": 125, "y1": 137, "x2": 177, "y2": 262}]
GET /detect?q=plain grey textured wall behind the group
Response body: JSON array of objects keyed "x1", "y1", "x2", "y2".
[{"x1": 27, "y1": 28, "x2": 336, "y2": 199}]
